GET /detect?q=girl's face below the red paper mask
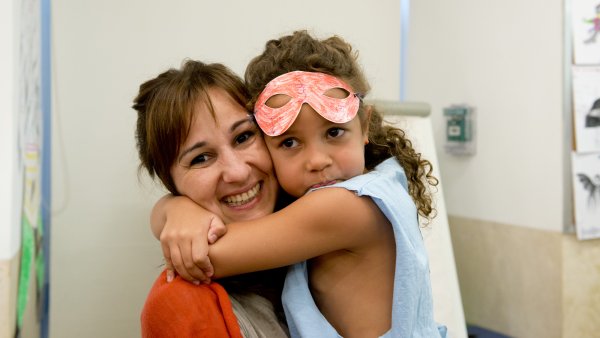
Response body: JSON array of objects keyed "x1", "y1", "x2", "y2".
[{"x1": 265, "y1": 93, "x2": 368, "y2": 197}]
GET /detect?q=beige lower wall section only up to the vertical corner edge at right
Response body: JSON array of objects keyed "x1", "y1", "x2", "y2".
[{"x1": 450, "y1": 217, "x2": 562, "y2": 338}]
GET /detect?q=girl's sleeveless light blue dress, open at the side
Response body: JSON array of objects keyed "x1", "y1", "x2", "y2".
[{"x1": 282, "y1": 158, "x2": 446, "y2": 338}]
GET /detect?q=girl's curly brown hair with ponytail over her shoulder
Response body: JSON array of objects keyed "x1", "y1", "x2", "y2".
[{"x1": 245, "y1": 31, "x2": 438, "y2": 220}]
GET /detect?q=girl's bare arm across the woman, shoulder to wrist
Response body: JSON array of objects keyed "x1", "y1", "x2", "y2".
[{"x1": 209, "y1": 188, "x2": 389, "y2": 277}]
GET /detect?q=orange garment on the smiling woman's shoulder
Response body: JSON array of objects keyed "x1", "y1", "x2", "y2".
[{"x1": 141, "y1": 271, "x2": 242, "y2": 338}]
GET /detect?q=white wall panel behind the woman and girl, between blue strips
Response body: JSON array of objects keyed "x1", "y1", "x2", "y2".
[{"x1": 50, "y1": 0, "x2": 400, "y2": 338}]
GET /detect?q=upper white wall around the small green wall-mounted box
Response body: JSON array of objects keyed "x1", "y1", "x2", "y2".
[{"x1": 407, "y1": 0, "x2": 570, "y2": 231}]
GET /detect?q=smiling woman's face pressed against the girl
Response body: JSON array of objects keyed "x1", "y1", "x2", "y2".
[{"x1": 171, "y1": 88, "x2": 278, "y2": 223}]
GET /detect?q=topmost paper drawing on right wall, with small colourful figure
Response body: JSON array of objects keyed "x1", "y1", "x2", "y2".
[{"x1": 571, "y1": 0, "x2": 600, "y2": 65}]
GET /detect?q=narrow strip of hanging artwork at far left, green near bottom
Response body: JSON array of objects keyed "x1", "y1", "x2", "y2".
[{"x1": 15, "y1": 0, "x2": 50, "y2": 337}]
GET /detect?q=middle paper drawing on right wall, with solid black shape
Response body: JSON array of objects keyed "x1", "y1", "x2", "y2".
[{"x1": 572, "y1": 65, "x2": 600, "y2": 153}]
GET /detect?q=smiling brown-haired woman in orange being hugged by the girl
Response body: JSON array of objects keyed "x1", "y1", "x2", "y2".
[{"x1": 133, "y1": 61, "x2": 287, "y2": 337}]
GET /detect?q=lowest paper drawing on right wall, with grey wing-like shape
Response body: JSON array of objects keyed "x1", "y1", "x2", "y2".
[{"x1": 572, "y1": 153, "x2": 600, "y2": 239}]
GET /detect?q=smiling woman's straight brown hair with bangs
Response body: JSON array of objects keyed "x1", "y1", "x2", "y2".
[{"x1": 133, "y1": 60, "x2": 249, "y2": 195}]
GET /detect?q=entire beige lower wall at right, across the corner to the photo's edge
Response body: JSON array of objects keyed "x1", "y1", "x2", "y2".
[{"x1": 450, "y1": 217, "x2": 600, "y2": 338}]
